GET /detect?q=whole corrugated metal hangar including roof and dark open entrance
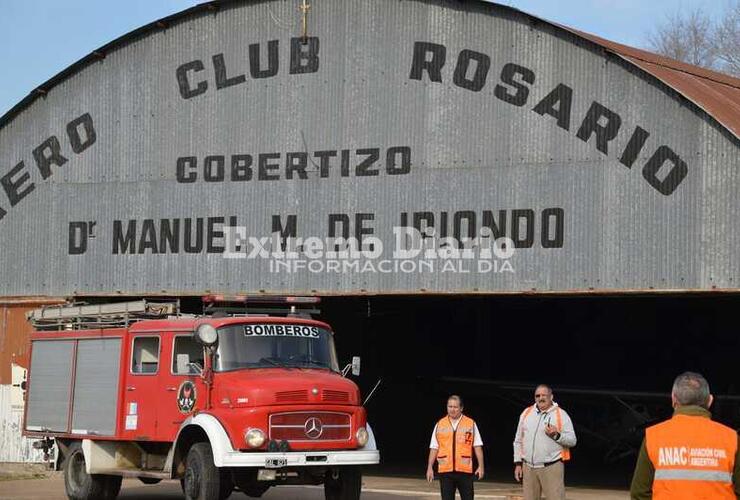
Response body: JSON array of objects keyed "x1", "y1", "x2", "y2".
[{"x1": 0, "y1": 0, "x2": 740, "y2": 482}]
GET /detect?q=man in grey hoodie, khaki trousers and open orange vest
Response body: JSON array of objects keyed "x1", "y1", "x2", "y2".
[{"x1": 514, "y1": 384, "x2": 576, "y2": 500}]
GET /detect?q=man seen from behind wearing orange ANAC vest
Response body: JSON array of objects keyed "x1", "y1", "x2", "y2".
[{"x1": 630, "y1": 372, "x2": 740, "y2": 500}]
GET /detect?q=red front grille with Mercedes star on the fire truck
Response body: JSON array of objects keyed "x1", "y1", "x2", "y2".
[{"x1": 269, "y1": 411, "x2": 352, "y2": 441}]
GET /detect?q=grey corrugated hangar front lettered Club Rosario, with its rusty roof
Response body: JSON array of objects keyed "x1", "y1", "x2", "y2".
[{"x1": 0, "y1": 0, "x2": 740, "y2": 296}]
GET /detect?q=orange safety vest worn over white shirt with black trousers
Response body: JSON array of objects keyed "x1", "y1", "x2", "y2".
[{"x1": 436, "y1": 415, "x2": 475, "y2": 474}]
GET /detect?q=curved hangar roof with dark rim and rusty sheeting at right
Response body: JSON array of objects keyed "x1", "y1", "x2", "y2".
[{"x1": 0, "y1": 0, "x2": 740, "y2": 137}]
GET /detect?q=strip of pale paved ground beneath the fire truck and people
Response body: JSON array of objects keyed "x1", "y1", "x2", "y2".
[{"x1": 0, "y1": 474, "x2": 629, "y2": 500}]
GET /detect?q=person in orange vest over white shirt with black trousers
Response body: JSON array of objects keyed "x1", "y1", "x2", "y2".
[{"x1": 427, "y1": 395, "x2": 483, "y2": 500}]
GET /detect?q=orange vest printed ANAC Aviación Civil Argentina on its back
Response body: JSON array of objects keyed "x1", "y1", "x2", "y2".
[{"x1": 645, "y1": 414, "x2": 738, "y2": 500}]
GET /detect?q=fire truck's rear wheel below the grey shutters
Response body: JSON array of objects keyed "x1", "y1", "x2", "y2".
[{"x1": 63, "y1": 443, "x2": 123, "y2": 500}]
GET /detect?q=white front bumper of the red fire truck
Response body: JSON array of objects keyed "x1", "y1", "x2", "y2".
[{"x1": 221, "y1": 450, "x2": 380, "y2": 468}]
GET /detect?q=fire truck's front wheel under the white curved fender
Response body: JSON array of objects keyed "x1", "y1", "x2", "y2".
[{"x1": 182, "y1": 443, "x2": 225, "y2": 500}]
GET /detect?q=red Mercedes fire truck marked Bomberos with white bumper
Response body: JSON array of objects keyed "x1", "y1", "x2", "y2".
[{"x1": 24, "y1": 297, "x2": 380, "y2": 500}]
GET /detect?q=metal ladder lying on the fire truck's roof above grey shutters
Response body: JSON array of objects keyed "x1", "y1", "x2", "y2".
[{"x1": 26, "y1": 299, "x2": 180, "y2": 331}]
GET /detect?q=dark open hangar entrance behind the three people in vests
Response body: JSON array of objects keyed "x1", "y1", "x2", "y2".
[{"x1": 321, "y1": 295, "x2": 740, "y2": 485}]
